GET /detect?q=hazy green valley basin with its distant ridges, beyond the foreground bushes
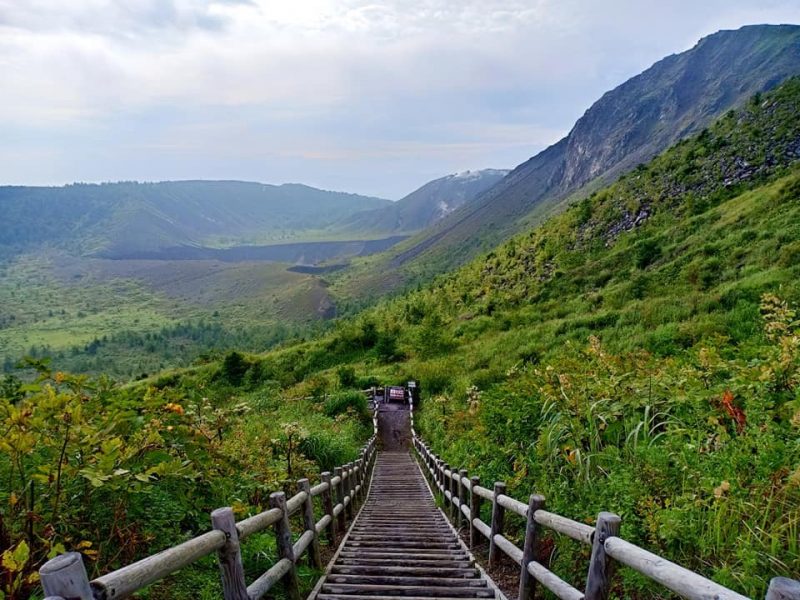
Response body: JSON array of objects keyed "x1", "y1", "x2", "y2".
[{"x1": 0, "y1": 170, "x2": 505, "y2": 378}]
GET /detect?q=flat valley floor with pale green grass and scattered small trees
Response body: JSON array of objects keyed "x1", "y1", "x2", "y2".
[{"x1": 0, "y1": 252, "x2": 335, "y2": 379}]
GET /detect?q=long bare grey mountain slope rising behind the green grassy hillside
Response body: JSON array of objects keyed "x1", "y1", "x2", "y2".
[{"x1": 355, "y1": 25, "x2": 800, "y2": 286}]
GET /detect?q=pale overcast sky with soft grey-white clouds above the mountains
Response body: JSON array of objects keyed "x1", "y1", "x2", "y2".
[{"x1": 0, "y1": 0, "x2": 800, "y2": 199}]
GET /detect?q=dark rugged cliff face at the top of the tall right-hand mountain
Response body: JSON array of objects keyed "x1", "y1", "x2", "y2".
[{"x1": 556, "y1": 25, "x2": 800, "y2": 192}]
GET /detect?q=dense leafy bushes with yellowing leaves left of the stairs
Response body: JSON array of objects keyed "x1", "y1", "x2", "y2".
[{"x1": 0, "y1": 353, "x2": 371, "y2": 600}]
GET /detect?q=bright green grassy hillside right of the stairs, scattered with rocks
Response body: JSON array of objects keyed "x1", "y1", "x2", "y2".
[{"x1": 214, "y1": 80, "x2": 800, "y2": 597}]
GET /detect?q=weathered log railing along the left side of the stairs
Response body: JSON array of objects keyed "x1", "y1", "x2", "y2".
[{"x1": 39, "y1": 436, "x2": 376, "y2": 600}]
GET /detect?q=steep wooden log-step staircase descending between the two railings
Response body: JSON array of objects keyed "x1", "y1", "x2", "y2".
[{"x1": 316, "y1": 451, "x2": 496, "y2": 600}]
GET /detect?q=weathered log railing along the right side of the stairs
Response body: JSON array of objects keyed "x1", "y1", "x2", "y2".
[{"x1": 412, "y1": 436, "x2": 800, "y2": 600}]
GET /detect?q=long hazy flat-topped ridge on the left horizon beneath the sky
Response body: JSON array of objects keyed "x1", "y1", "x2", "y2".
[{"x1": 0, "y1": 181, "x2": 391, "y2": 259}]
